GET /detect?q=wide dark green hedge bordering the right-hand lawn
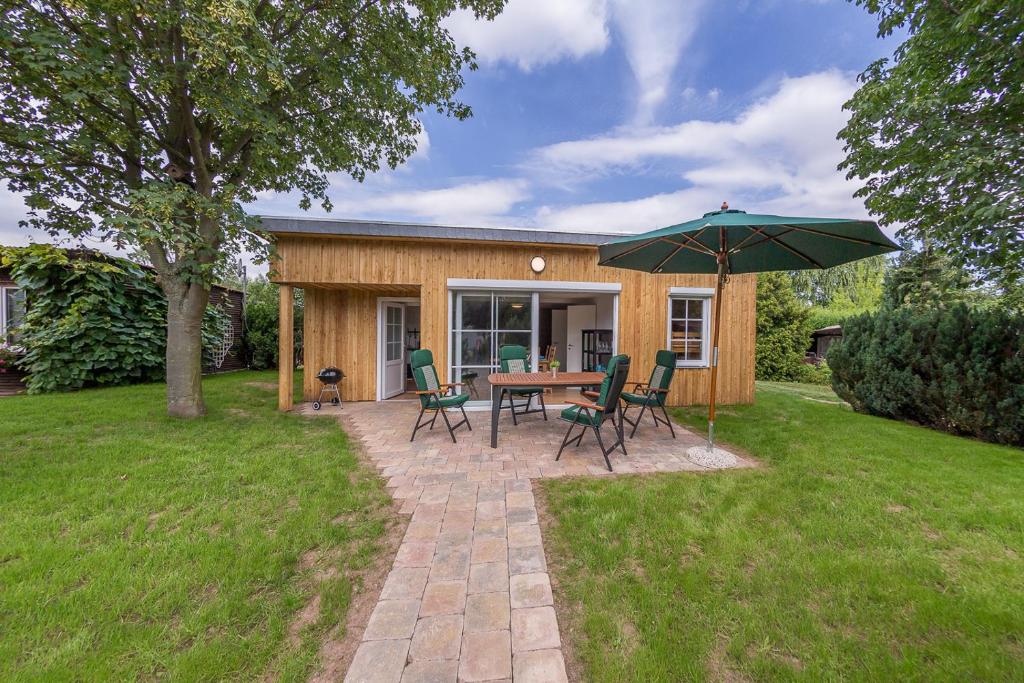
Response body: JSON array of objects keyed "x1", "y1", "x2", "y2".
[{"x1": 827, "y1": 304, "x2": 1024, "y2": 445}]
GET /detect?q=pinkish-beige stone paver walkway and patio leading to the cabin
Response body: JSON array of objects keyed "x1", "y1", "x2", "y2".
[{"x1": 303, "y1": 401, "x2": 751, "y2": 683}]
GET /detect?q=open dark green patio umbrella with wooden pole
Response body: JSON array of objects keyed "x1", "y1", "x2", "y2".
[{"x1": 599, "y1": 203, "x2": 900, "y2": 451}]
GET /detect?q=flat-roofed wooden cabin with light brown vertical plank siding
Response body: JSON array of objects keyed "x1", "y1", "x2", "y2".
[{"x1": 262, "y1": 217, "x2": 756, "y2": 410}]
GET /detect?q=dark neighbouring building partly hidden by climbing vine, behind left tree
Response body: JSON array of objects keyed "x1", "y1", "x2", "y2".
[{"x1": 0, "y1": 249, "x2": 246, "y2": 396}]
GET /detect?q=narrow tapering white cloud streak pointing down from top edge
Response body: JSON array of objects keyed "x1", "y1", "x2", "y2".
[{"x1": 611, "y1": 0, "x2": 705, "y2": 123}]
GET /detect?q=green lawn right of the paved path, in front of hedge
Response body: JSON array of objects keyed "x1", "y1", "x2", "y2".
[{"x1": 544, "y1": 384, "x2": 1024, "y2": 681}]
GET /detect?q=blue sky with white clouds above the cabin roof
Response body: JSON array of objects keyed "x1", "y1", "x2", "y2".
[{"x1": 0, "y1": 0, "x2": 896, "y2": 252}]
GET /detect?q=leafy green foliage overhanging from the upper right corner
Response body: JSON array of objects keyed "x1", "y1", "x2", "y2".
[{"x1": 840, "y1": 0, "x2": 1024, "y2": 299}]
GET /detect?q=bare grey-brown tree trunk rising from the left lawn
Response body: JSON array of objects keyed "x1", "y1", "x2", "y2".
[{"x1": 164, "y1": 284, "x2": 210, "y2": 418}]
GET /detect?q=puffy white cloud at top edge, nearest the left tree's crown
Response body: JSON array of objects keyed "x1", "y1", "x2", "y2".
[{"x1": 446, "y1": 0, "x2": 608, "y2": 71}]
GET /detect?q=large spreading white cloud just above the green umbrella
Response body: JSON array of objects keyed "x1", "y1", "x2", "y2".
[{"x1": 529, "y1": 72, "x2": 867, "y2": 230}]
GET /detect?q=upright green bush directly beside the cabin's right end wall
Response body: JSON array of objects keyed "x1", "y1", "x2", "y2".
[{"x1": 754, "y1": 272, "x2": 811, "y2": 382}]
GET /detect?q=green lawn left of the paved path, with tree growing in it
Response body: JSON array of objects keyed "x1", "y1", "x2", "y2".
[{"x1": 0, "y1": 373, "x2": 390, "y2": 681}]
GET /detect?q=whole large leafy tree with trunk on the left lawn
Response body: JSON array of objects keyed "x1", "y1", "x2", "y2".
[{"x1": 0, "y1": 0, "x2": 504, "y2": 416}]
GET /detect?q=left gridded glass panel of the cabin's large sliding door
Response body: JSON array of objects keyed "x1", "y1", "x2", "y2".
[{"x1": 450, "y1": 291, "x2": 534, "y2": 400}]
